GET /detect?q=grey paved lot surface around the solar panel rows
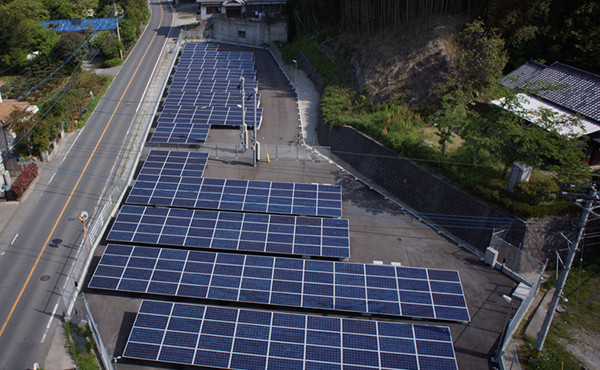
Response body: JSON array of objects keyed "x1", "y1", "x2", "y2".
[{"x1": 84, "y1": 42, "x2": 517, "y2": 369}]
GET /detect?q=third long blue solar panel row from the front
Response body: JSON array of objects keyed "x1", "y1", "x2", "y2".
[{"x1": 107, "y1": 204, "x2": 350, "y2": 258}]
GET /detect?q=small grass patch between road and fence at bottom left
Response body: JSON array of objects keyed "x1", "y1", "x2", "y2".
[{"x1": 65, "y1": 321, "x2": 101, "y2": 370}]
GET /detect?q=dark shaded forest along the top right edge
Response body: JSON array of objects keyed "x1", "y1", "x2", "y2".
[{"x1": 290, "y1": 0, "x2": 600, "y2": 73}]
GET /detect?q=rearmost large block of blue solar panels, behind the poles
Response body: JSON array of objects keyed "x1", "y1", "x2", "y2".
[{"x1": 149, "y1": 44, "x2": 262, "y2": 145}]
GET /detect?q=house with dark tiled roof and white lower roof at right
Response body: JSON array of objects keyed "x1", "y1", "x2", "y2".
[{"x1": 493, "y1": 61, "x2": 600, "y2": 165}]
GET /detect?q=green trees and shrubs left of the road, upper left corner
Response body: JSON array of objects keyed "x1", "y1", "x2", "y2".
[{"x1": 0, "y1": 0, "x2": 150, "y2": 156}]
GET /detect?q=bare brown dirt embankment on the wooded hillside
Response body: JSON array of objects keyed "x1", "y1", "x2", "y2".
[{"x1": 340, "y1": 17, "x2": 466, "y2": 108}]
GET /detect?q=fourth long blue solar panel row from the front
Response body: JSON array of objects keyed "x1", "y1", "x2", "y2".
[{"x1": 126, "y1": 176, "x2": 342, "y2": 217}]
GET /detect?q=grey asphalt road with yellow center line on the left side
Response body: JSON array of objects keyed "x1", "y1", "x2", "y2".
[{"x1": 0, "y1": 1, "x2": 173, "y2": 369}]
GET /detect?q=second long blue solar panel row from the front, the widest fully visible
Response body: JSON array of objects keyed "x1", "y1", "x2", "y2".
[{"x1": 88, "y1": 244, "x2": 470, "y2": 322}]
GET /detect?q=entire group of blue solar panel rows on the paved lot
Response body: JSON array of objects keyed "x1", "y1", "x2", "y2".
[{"x1": 109, "y1": 44, "x2": 470, "y2": 369}]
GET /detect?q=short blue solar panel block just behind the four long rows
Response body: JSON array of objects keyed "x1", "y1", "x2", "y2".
[{"x1": 137, "y1": 150, "x2": 208, "y2": 184}]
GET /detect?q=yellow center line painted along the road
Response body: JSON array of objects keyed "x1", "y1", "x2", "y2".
[{"x1": 0, "y1": 2, "x2": 164, "y2": 337}]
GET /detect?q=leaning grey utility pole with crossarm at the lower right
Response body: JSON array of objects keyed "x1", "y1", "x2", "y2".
[{"x1": 531, "y1": 186, "x2": 598, "y2": 359}]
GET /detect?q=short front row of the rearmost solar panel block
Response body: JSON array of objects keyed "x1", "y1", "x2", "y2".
[{"x1": 148, "y1": 122, "x2": 210, "y2": 145}]
